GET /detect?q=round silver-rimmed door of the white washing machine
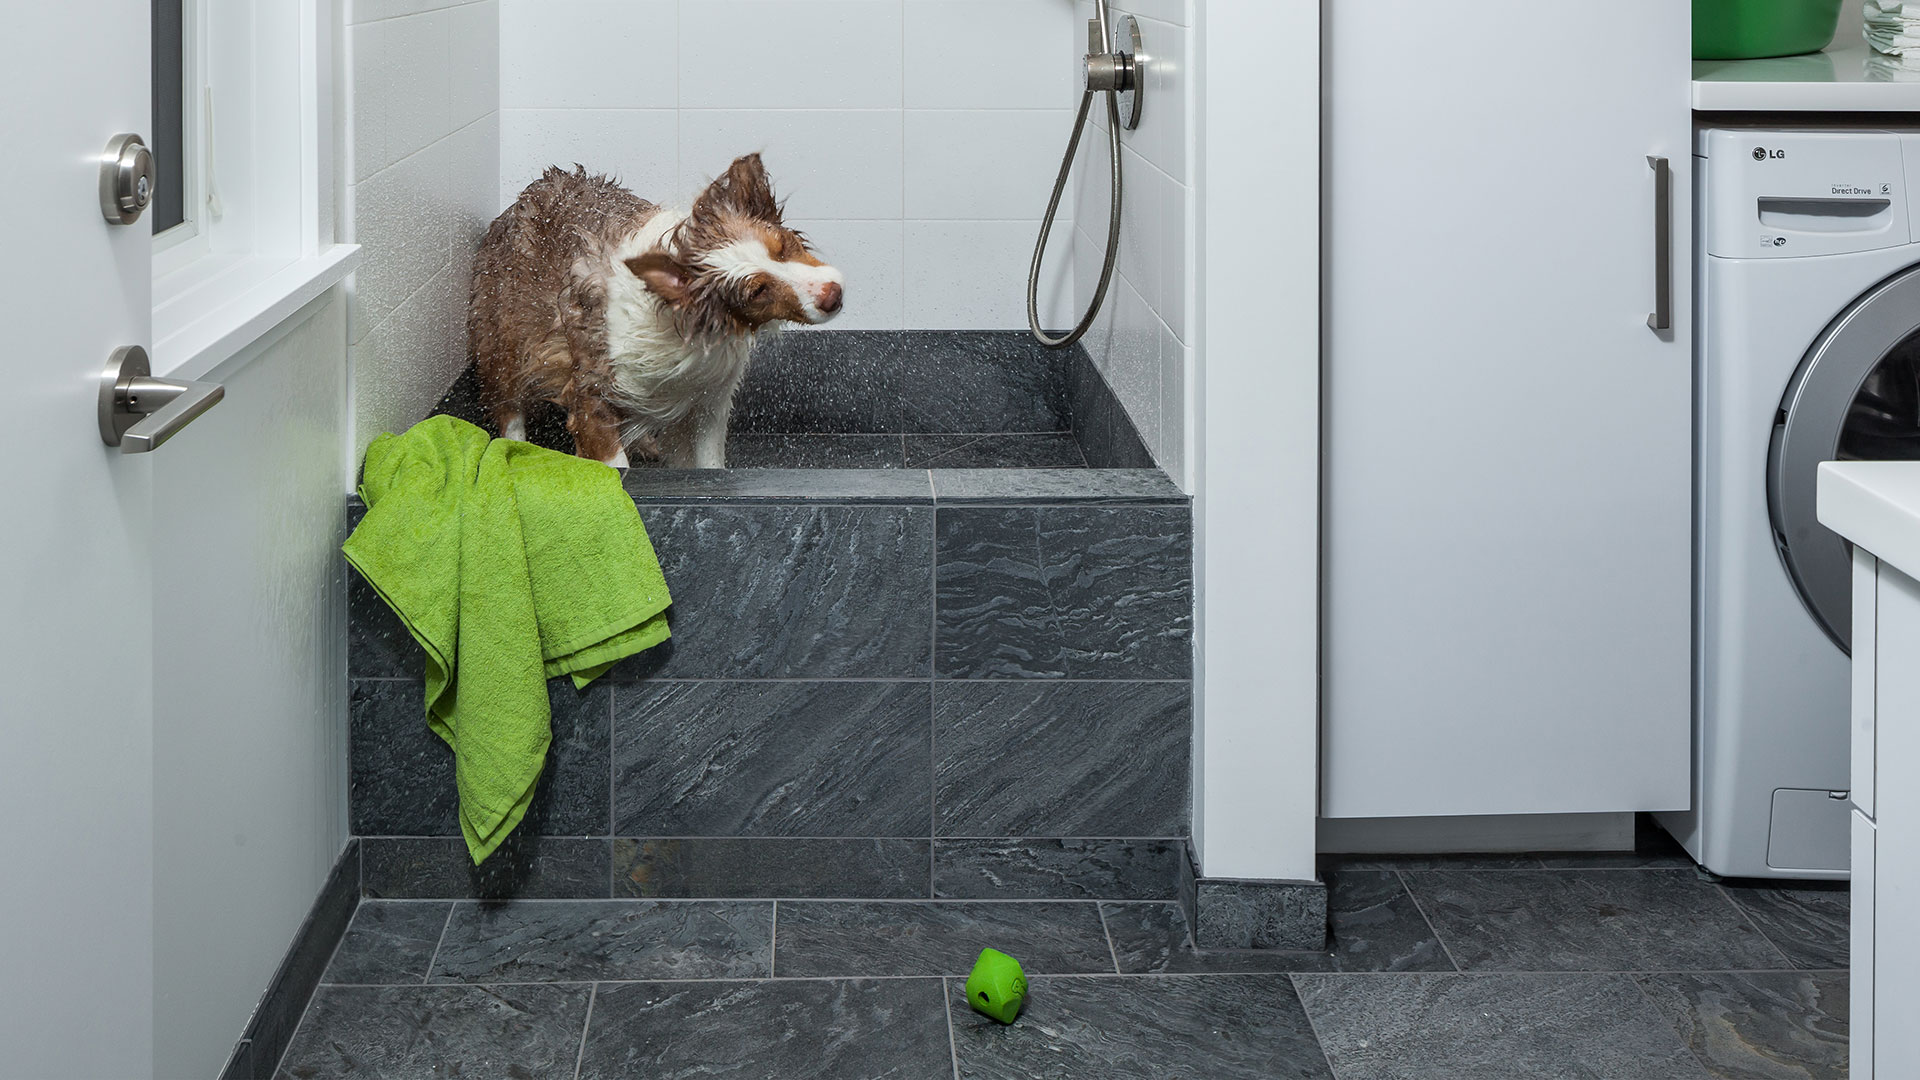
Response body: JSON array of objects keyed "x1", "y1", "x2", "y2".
[{"x1": 1766, "y1": 267, "x2": 1920, "y2": 653}]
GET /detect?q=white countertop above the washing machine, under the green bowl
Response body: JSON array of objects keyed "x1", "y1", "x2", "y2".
[{"x1": 1693, "y1": 38, "x2": 1920, "y2": 113}]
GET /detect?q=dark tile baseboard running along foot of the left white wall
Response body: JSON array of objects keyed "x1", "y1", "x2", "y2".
[{"x1": 221, "y1": 838, "x2": 361, "y2": 1080}]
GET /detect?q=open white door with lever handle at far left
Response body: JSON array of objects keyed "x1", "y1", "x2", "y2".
[{"x1": 0, "y1": 0, "x2": 154, "y2": 1078}]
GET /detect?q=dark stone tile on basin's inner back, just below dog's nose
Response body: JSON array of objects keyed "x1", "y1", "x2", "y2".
[{"x1": 732, "y1": 331, "x2": 902, "y2": 432}]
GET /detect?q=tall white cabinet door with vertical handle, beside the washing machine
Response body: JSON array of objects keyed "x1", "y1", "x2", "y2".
[{"x1": 1323, "y1": 0, "x2": 1692, "y2": 817}]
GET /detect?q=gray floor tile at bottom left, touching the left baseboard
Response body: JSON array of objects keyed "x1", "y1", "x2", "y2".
[{"x1": 276, "y1": 986, "x2": 591, "y2": 1080}]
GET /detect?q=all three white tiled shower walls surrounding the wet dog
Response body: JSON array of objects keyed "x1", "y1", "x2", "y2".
[{"x1": 344, "y1": 0, "x2": 1192, "y2": 480}]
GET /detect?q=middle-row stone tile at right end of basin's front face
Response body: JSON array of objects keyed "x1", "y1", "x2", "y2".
[{"x1": 933, "y1": 682, "x2": 1192, "y2": 838}]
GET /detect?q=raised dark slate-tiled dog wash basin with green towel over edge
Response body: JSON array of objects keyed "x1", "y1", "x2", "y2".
[{"x1": 349, "y1": 332, "x2": 1192, "y2": 899}]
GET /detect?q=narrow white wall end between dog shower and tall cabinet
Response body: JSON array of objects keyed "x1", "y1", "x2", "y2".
[{"x1": 1194, "y1": 0, "x2": 1321, "y2": 880}]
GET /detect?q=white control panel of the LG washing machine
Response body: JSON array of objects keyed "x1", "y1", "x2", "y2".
[{"x1": 1695, "y1": 127, "x2": 1920, "y2": 259}]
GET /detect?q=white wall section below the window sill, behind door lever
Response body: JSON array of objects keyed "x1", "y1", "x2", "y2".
[{"x1": 152, "y1": 290, "x2": 348, "y2": 1078}]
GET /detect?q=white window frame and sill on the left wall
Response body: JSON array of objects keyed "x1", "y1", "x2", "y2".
[{"x1": 152, "y1": 0, "x2": 359, "y2": 379}]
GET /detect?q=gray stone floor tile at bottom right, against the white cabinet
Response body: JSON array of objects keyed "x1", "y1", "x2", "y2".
[{"x1": 1638, "y1": 972, "x2": 1847, "y2": 1080}]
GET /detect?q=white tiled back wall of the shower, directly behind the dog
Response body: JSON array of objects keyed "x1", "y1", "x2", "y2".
[{"x1": 497, "y1": 0, "x2": 1079, "y2": 329}]
